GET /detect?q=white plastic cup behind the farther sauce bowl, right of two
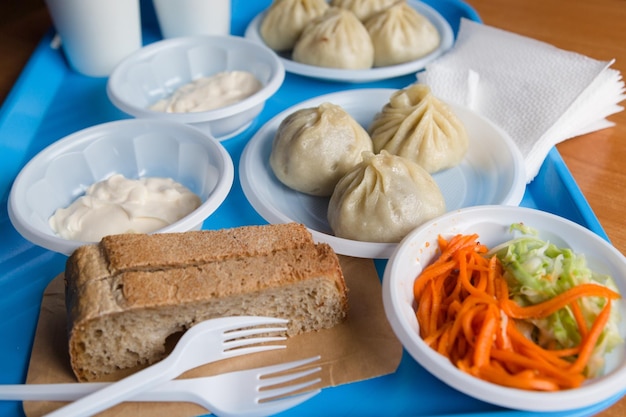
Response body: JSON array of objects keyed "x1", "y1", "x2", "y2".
[{"x1": 153, "y1": 0, "x2": 231, "y2": 39}]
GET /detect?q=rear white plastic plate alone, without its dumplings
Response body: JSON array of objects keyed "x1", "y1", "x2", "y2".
[{"x1": 244, "y1": 0, "x2": 454, "y2": 82}]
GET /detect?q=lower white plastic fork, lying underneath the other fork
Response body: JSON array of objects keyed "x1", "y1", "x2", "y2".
[{"x1": 0, "y1": 356, "x2": 321, "y2": 417}]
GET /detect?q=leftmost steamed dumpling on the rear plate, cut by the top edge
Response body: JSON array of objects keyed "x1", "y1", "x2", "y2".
[{"x1": 260, "y1": 0, "x2": 329, "y2": 52}]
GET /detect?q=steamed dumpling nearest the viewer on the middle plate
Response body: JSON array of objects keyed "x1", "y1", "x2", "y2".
[{"x1": 328, "y1": 151, "x2": 446, "y2": 243}]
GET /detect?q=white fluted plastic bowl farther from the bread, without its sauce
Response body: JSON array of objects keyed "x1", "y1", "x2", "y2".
[{"x1": 107, "y1": 36, "x2": 285, "y2": 140}]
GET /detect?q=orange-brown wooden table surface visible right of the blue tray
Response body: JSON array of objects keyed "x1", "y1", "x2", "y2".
[{"x1": 468, "y1": 0, "x2": 626, "y2": 417}]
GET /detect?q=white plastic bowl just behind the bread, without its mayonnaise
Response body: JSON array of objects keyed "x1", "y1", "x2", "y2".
[{"x1": 8, "y1": 119, "x2": 234, "y2": 255}]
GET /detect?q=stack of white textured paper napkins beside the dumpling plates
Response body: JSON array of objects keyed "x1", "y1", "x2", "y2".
[{"x1": 417, "y1": 19, "x2": 626, "y2": 182}]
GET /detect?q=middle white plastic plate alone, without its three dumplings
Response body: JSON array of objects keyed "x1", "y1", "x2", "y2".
[{"x1": 239, "y1": 89, "x2": 526, "y2": 258}]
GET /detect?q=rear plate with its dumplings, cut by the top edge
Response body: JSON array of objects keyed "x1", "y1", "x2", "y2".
[{"x1": 244, "y1": 0, "x2": 454, "y2": 82}]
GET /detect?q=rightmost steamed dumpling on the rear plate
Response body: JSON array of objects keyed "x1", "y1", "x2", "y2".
[{"x1": 365, "y1": 1, "x2": 440, "y2": 67}]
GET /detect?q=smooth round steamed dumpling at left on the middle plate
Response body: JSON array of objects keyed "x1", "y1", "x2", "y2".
[{"x1": 270, "y1": 103, "x2": 373, "y2": 196}]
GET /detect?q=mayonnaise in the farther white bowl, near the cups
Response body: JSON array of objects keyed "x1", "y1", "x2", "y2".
[{"x1": 150, "y1": 71, "x2": 263, "y2": 113}]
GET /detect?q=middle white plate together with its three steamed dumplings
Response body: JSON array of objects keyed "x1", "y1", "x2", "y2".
[{"x1": 239, "y1": 83, "x2": 526, "y2": 259}]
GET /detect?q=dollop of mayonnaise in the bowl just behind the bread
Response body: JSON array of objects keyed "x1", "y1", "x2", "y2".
[{"x1": 49, "y1": 174, "x2": 201, "y2": 242}]
